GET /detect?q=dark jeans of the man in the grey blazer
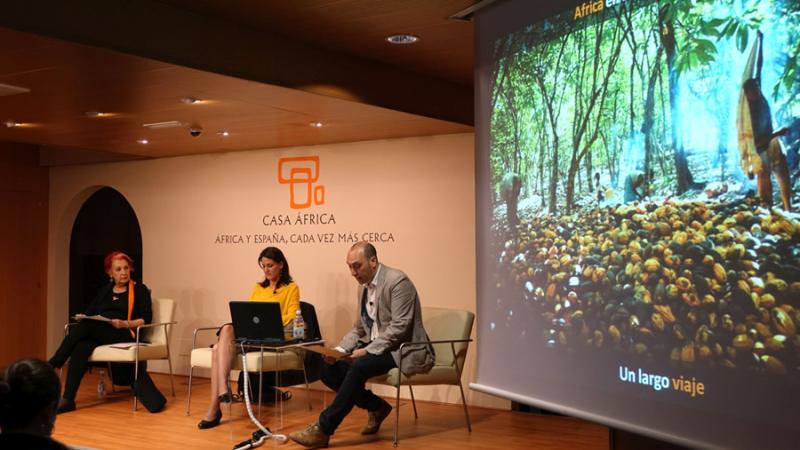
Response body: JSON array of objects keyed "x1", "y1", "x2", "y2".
[{"x1": 319, "y1": 353, "x2": 397, "y2": 435}]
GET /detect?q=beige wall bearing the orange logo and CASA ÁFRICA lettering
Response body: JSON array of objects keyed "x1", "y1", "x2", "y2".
[{"x1": 48, "y1": 134, "x2": 508, "y2": 407}]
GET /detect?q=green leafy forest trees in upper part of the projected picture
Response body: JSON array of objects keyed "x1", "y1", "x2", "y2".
[{"x1": 490, "y1": 0, "x2": 800, "y2": 204}]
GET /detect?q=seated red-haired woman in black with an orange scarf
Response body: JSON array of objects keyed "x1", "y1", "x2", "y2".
[{"x1": 48, "y1": 252, "x2": 153, "y2": 413}]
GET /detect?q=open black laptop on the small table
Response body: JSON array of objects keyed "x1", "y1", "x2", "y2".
[{"x1": 230, "y1": 301, "x2": 295, "y2": 345}]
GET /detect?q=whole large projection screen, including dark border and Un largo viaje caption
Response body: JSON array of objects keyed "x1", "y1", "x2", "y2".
[{"x1": 472, "y1": 0, "x2": 800, "y2": 449}]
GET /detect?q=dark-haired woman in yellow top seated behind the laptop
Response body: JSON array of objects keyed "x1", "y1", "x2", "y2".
[{"x1": 197, "y1": 247, "x2": 300, "y2": 429}]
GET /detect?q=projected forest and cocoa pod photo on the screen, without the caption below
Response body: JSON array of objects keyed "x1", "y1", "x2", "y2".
[{"x1": 490, "y1": 0, "x2": 800, "y2": 378}]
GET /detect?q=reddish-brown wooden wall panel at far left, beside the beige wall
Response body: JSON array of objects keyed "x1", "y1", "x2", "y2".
[{"x1": 0, "y1": 142, "x2": 49, "y2": 367}]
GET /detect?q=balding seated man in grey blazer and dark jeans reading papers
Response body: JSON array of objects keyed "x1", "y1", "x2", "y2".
[{"x1": 289, "y1": 242, "x2": 435, "y2": 448}]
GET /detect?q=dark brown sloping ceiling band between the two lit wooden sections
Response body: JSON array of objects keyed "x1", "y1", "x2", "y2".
[{"x1": 0, "y1": 0, "x2": 474, "y2": 125}]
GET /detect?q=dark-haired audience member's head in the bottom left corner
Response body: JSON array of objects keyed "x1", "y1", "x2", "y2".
[{"x1": 0, "y1": 359, "x2": 61, "y2": 436}]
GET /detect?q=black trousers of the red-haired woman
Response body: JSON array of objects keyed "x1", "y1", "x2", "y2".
[{"x1": 49, "y1": 320, "x2": 134, "y2": 400}]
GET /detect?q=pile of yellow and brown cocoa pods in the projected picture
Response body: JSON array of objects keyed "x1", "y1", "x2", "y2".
[{"x1": 496, "y1": 198, "x2": 800, "y2": 376}]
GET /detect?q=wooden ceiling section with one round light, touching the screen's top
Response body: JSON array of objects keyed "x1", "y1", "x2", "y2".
[{"x1": 161, "y1": 0, "x2": 477, "y2": 86}]
